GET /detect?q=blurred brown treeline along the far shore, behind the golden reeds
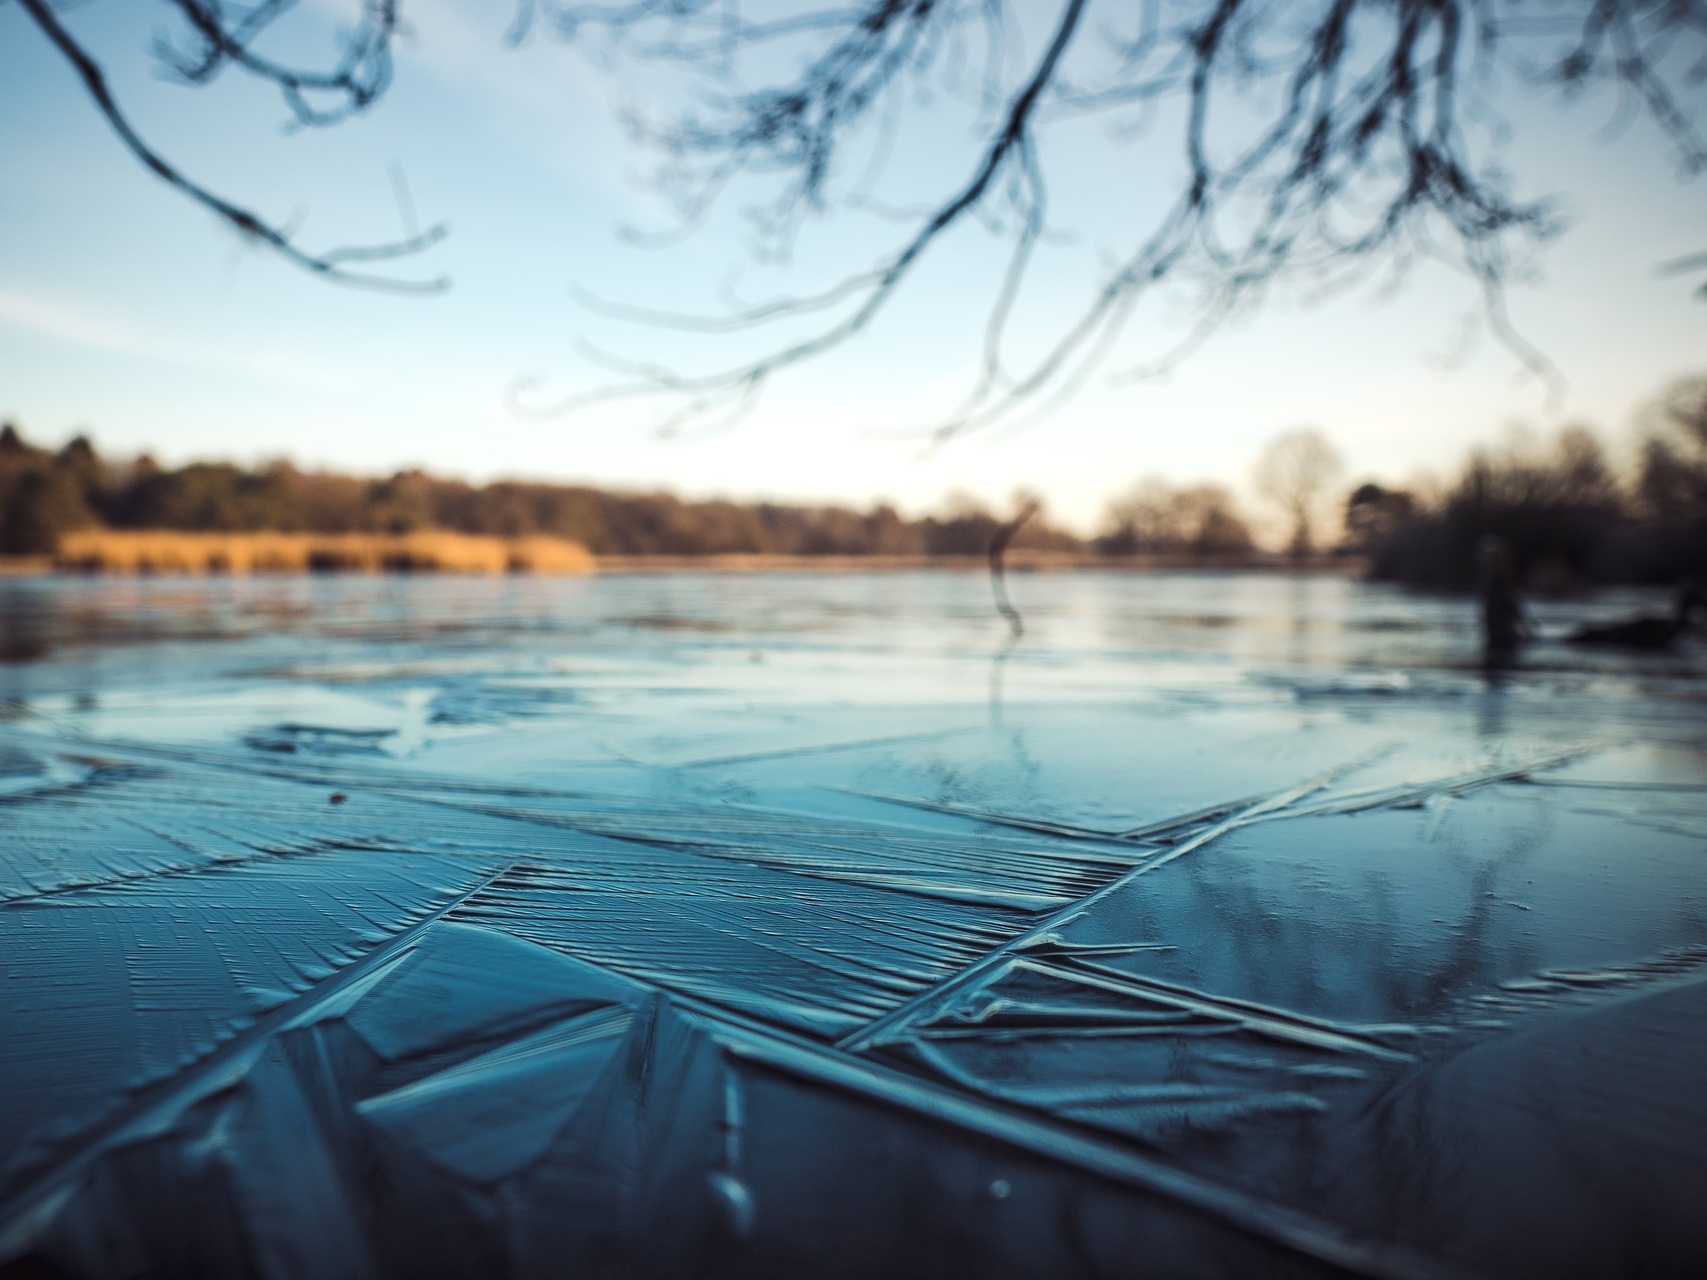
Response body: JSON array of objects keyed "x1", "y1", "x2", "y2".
[{"x1": 0, "y1": 377, "x2": 1707, "y2": 591}]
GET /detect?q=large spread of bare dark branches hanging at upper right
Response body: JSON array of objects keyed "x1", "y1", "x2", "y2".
[{"x1": 529, "y1": 0, "x2": 1707, "y2": 439}]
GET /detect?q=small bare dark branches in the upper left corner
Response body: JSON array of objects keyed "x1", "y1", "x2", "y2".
[{"x1": 19, "y1": 0, "x2": 449, "y2": 294}]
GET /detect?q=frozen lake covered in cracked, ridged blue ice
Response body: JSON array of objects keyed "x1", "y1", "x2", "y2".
[{"x1": 0, "y1": 572, "x2": 1707, "y2": 1277}]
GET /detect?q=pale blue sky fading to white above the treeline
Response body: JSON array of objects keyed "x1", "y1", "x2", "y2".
[{"x1": 0, "y1": 0, "x2": 1707, "y2": 532}]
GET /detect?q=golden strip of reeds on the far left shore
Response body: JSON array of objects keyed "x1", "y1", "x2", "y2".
[{"x1": 55, "y1": 529, "x2": 597, "y2": 573}]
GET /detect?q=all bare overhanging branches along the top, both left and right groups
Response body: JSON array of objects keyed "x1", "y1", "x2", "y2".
[{"x1": 19, "y1": 0, "x2": 1707, "y2": 437}]
